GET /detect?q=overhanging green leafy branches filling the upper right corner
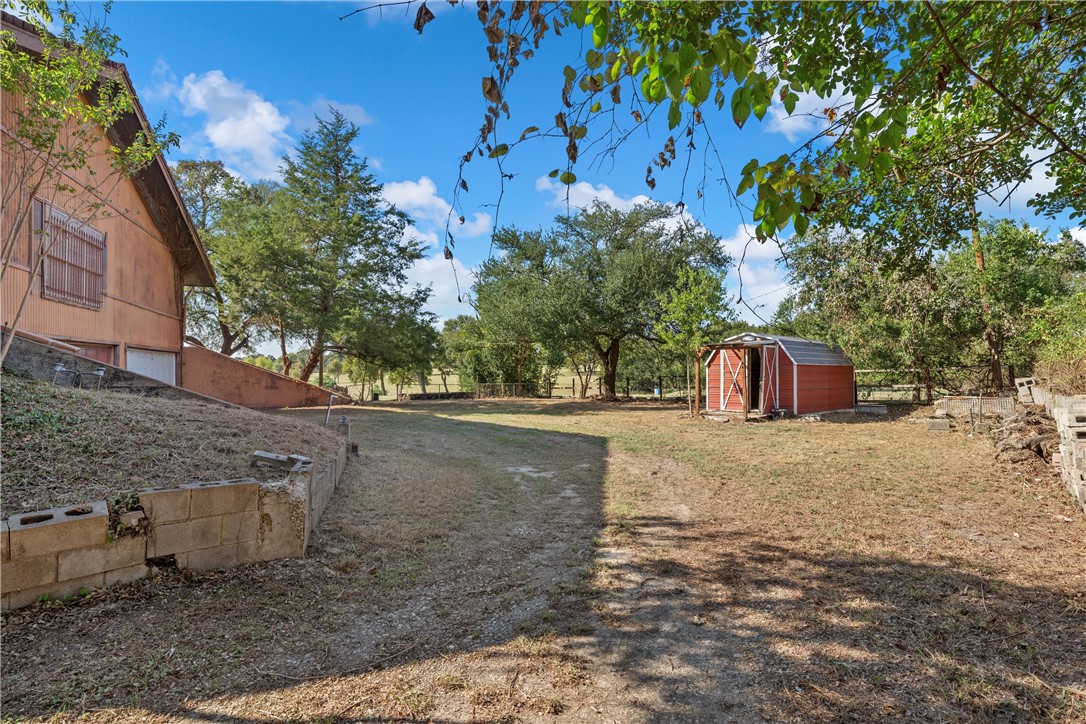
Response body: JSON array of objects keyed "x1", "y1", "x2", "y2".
[{"x1": 403, "y1": 0, "x2": 1086, "y2": 257}]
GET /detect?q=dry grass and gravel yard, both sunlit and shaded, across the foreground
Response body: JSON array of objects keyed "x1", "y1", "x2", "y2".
[{"x1": 2, "y1": 401, "x2": 1086, "y2": 723}]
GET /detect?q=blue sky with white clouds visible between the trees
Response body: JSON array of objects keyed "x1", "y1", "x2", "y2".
[{"x1": 90, "y1": 0, "x2": 1077, "y2": 343}]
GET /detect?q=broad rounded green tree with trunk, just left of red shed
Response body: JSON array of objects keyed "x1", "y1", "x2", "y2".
[{"x1": 475, "y1": 202, "x2": 731, "y2": 397}]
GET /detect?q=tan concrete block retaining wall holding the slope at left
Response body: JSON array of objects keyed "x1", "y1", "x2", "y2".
[{"x1": 0, "y1": 424, "x2": 350, "y2": 611}]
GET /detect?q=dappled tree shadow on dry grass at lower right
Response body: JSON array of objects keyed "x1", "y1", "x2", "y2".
[{"x1": 586, "y1": 518, "x2": 1086, "y2": 722}]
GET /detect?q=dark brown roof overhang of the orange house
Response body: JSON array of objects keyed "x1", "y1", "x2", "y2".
[{"x1": 2, "y1": 13, "x2": 215, "y2": 287}]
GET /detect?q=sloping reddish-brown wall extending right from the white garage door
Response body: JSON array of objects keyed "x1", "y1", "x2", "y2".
[{"x1": 181, "y1": 346, "x2": 332, "y2": 408}]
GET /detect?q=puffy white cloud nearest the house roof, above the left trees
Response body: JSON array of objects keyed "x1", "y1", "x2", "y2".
[{"x1": 177, "y1": 71, "x2": 291, "y2": 178}]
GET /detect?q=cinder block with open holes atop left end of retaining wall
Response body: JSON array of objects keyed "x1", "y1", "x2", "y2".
[{"x1": 8, "y1": 500, "x2": 110, "y2": 560}]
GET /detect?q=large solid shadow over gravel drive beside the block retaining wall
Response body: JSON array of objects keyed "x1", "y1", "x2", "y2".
[{"x1": 2, "y1": 407, "x2": 607, "y2": 722}]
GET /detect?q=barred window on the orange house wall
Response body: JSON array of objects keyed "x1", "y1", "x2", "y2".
[{"x1": 35, "y1": 202, "x2": 105, "y2": 309}]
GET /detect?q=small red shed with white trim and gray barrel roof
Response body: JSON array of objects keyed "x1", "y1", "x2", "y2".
[{"x1": 705, "y1": 332, "x2": 856, "y2": 415}]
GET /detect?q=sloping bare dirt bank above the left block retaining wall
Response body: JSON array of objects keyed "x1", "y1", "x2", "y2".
[{"x1": 0, "y1": 374, "x2": 339, "y2": 518}]
